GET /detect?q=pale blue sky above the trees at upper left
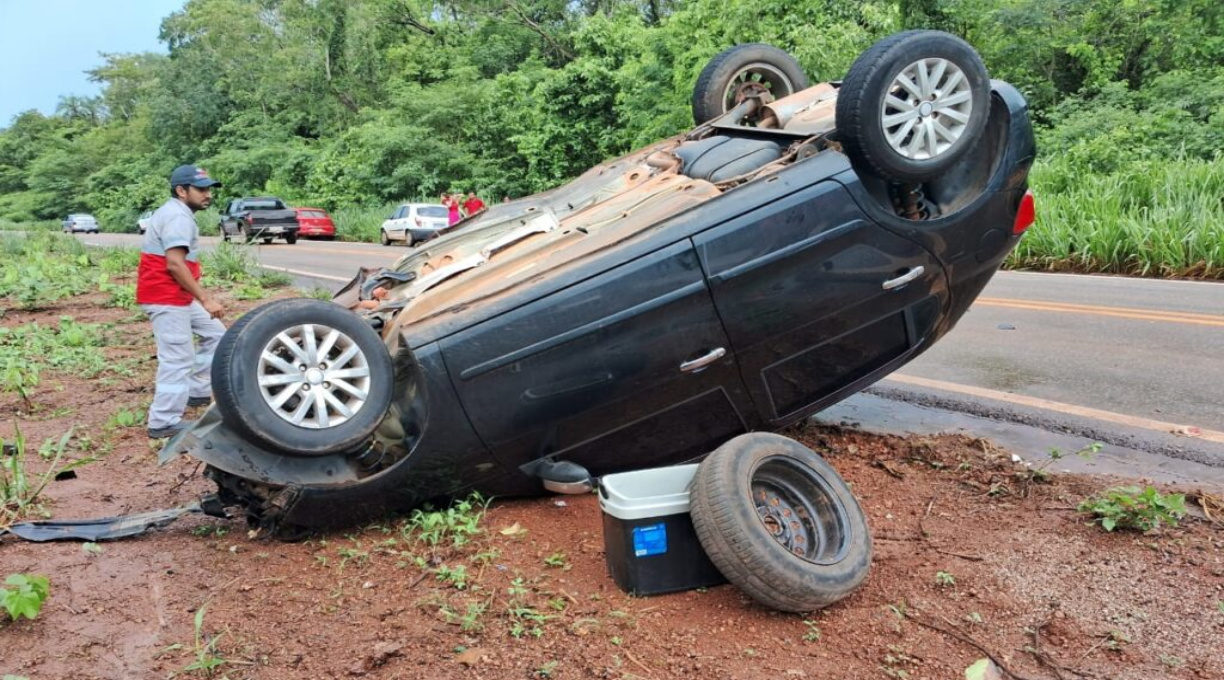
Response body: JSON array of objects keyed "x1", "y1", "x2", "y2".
[{"x1": 0, "y1": 0, "x2": 185, "y2": 128}]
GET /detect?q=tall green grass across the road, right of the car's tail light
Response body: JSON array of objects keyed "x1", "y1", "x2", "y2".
[{"x1": 1009, "y1": 157, "x2": 1224, "y2": 279}]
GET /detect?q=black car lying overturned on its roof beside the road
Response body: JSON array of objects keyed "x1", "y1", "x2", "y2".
[{"x1": 163, "y1": 31, "x2": 1036, "y2": 609}]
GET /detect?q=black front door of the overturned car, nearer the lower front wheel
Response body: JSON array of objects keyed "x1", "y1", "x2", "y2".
[{"x1": 442, "y1": 241, "x2": 753, "y2": 475}]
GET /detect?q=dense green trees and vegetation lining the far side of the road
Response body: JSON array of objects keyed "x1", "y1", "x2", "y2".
[{"x1": 0, "y1": 0, "x2": 1224, "y2": 276}]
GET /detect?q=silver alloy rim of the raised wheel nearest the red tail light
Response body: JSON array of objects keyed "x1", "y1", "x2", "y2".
[{"x1": 880, "y1": 57, "x2": 973, "y2": 160}]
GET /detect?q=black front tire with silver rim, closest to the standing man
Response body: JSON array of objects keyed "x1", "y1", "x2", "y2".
[{"x1": 212, "y1": 298, "x2": 394, "y2": 456}]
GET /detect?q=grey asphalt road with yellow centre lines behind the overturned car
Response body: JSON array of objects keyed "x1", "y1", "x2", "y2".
[{"x1": 78, "y1": 234, "x2": 1224, "y2": 462}]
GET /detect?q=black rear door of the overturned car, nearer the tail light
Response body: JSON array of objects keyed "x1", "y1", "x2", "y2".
[{"x1": 694, "y1": 181, "x2": 947, "y2": 427}]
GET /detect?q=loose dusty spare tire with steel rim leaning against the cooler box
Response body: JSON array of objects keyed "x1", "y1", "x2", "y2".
[{"x1": 689, "y1": 432, "x2": 871, "y2": 612}]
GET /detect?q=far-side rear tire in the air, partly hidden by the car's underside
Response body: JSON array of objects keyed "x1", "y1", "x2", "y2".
[{"x1": 693, "y1": 43, "x2": 808, "y2": 125}]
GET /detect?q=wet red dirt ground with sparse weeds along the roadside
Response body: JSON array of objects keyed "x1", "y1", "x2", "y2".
[{"x1": 0, "y1": 289, "x2": 1224, "y2": 680}]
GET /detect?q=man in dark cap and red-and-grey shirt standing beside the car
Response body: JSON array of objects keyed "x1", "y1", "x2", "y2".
[{"x1": 136, "y1": 165, "x2": 225, "y2": 439}]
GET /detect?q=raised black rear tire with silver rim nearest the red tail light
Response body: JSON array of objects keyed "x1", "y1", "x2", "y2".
[{"x1": 836, "y1": 31, "x2": 990, "y2": 182}]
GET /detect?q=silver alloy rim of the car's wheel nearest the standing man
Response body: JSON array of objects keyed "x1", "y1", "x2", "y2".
[{"x1": 257, "y1": 324, "x2": 370, "y2": 429}]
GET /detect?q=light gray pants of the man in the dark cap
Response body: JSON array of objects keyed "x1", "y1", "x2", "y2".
[{"x1": 141, "y1": 301, "x2": 225, "y2": 429}]
